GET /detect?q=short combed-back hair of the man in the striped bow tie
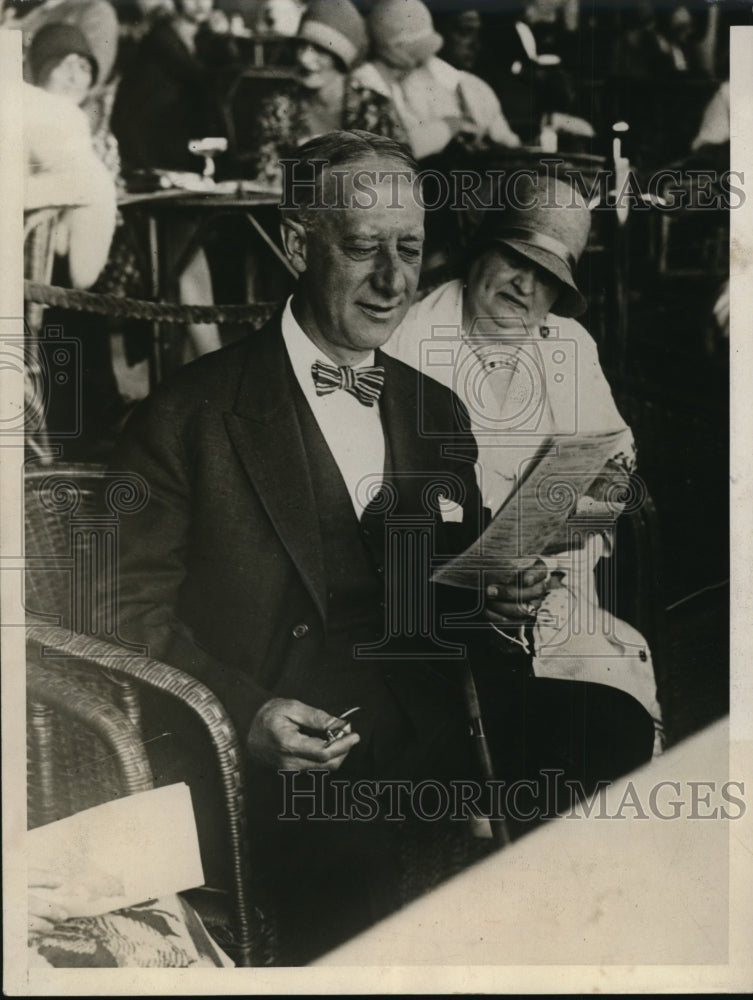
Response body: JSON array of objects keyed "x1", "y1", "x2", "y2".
[{"x1": 280, "y1": 129, "x2": 419, "y2": 225}]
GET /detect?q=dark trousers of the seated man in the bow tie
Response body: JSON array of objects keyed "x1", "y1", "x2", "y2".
[{"x1": 249, "y1": 670, "x2": 653, "y2": 965}]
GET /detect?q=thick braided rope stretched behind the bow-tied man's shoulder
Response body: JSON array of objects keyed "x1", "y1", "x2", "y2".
[{"x1": 24, "y1": 280, "x2": 279, "y2": 326}]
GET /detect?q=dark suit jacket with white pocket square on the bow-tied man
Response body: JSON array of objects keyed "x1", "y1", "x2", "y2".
[{"x1": 112, "y1": 317, "x2": 482, "y2": 740}]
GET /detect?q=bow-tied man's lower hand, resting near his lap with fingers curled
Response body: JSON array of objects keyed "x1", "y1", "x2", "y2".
[{"x1": 246, "y1": 698, "x2": 360, "y2": 771}]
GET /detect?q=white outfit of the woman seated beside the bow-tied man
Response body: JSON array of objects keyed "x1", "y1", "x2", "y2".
[{"x1": 383, "y1": 280, "x2": 661, "y2": 750}]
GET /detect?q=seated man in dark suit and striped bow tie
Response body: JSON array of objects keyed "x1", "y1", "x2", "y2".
[{"x1": 108, "y1": 131, "x2": 651, "y2": 964}]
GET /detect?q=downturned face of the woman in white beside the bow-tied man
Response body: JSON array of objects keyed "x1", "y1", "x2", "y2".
[{"x1": 466, "y1": 245, "x2": 560, "y2": 331}]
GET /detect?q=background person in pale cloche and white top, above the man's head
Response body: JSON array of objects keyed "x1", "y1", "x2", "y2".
[{"x1": 355, "y1": 0, "x2": 520, "y2": 160}]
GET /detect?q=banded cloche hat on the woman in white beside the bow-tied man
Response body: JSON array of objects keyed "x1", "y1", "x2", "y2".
[{"x1": 471, "y1": 173, "x2": 591, "y2": 316}]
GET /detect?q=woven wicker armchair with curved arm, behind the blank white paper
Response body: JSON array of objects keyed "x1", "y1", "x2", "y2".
[{"x1": 25, "y1": 466, "x2": 275, "y2": 965}]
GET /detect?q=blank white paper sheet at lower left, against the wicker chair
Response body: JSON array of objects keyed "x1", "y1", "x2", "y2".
[{"x1": 26, "y1": 782, "x2": 204, "y2": 917}]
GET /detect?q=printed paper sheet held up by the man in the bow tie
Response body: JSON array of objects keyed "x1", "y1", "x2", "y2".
[{"x1": 433, "y1": 430, "x2": 622, "y2": 588}]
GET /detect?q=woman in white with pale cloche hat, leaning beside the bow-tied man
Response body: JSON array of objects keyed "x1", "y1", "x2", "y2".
[{"x1": 384, "y1": 173, "x2": 661, "y2": 751}]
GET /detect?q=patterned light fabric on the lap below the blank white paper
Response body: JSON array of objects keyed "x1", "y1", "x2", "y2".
[{"x1": 29, "y1": 896, "x2": 233, "y2": 969}]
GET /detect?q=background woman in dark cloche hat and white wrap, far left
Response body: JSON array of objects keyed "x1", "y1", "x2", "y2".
[{"x1": 23, "y1": 24, "x2": 120, "y2": 459}]
